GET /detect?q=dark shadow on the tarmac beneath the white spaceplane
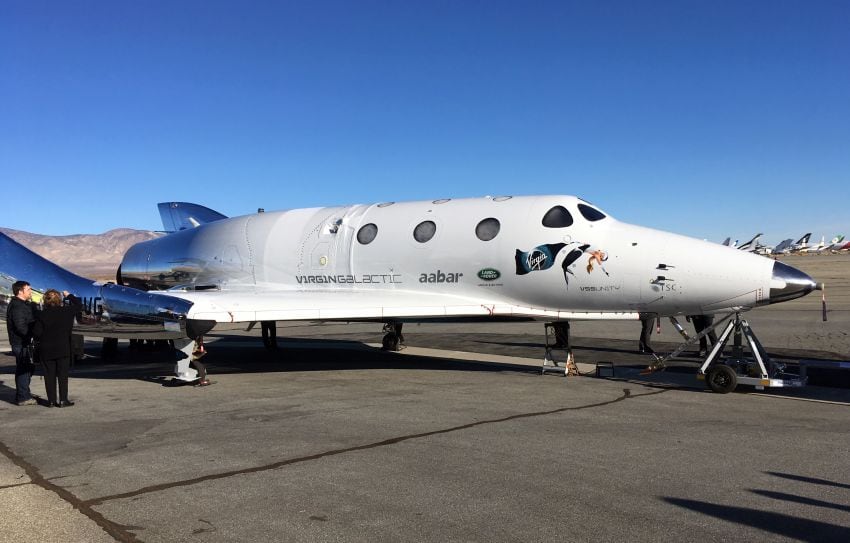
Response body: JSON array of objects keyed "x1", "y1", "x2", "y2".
[{"x1": 0, "y1": 334, "x2": 850, "y2": 397}]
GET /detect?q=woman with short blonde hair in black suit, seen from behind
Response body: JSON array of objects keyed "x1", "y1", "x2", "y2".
[{"x1": 33, "y1": 289, "x2": 81, "y2": 407}]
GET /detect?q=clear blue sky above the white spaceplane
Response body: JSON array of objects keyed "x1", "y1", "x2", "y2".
[{"x1": 0, "y1": 0, "x2": 850, "y2": 242}]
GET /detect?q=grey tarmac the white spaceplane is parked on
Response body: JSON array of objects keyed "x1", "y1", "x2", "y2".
[{"x1": 0, "y1": 257, "x2": 850, "y2": 542}]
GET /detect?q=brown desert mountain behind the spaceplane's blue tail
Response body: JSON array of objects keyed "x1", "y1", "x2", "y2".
[{"x1": 0, "y1": 228, "x2": 161, "y2": 281}]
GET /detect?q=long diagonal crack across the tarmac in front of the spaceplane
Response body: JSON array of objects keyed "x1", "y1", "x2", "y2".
[{"x1": 84, "y1": 388, "x2": 673, "y2": 506}]
